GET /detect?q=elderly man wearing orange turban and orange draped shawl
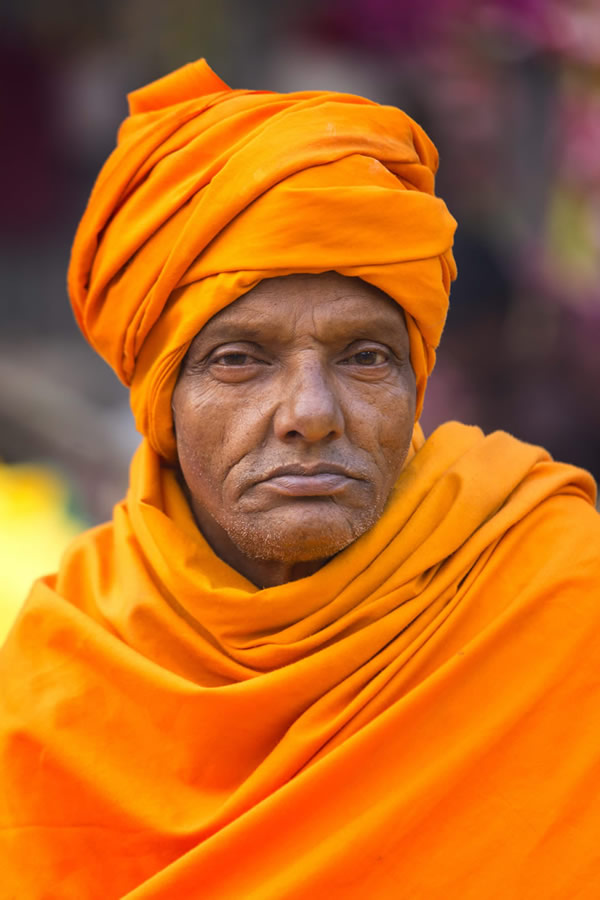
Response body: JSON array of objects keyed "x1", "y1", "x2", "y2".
[{"x1": 0, "y1": 62, "x2": 600, "y2": 900}]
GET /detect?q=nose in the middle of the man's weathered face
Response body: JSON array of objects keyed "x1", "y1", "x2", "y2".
[{"x1": 274, "y1": 359, "x2": 344, "y2": 444}]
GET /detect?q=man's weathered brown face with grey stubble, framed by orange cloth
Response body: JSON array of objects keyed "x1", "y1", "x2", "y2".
[{"x1": 173, "y1": 272, "x2": 416, "y2": 587}]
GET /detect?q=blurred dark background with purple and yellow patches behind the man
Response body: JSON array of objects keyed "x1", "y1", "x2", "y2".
[{"x1": 0, "y1": 0, "x2": 600, "y2": 624}]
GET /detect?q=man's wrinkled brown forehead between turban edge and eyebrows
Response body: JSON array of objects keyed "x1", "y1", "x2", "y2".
[{"x1": 194, "y1": 272, "x2": 407, "y2": 343}]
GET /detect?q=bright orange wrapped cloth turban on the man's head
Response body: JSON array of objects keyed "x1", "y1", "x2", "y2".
[{"x1": 69, "y1": 60, "x2": 455, "y2": 460}]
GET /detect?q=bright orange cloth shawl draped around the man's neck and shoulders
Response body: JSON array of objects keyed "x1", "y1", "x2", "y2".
[{"x1": 0, "y1": 423, "x2": 600, "y2": 900}]
